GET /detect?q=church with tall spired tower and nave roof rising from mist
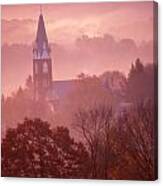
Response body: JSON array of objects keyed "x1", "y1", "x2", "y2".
[{"x1": 33, "y1": 13, "x2": 74, "y2": 102}]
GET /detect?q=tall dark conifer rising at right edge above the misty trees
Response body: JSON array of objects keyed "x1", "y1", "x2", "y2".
[{"x1": 126, "y1": 59, "x2": 156, "y2": 103}]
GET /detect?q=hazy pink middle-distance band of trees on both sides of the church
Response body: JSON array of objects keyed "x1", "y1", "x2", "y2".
[{"x1": 1, "y1": 59, "x2": 156, "y2": 133}]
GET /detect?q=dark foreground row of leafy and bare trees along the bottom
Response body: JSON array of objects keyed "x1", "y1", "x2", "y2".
[{"x1": 2, "y1": 102, "x2": 156, "y2": 180}]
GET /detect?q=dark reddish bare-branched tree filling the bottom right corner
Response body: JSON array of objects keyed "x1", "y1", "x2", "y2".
[{"x1": 118, "y1": 102, "x2": 157, "y2": 180}]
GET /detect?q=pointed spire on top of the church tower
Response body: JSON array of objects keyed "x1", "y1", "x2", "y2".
[{"x1": 34, "y1": 14, "x2": 50, "y2": 58}]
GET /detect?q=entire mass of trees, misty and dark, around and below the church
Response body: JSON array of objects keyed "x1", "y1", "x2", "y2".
[{"x1": 1, "y1": 58, "x2": 157, "y2": 180}]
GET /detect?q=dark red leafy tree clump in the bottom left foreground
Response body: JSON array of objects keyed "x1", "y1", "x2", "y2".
[{"x1": 2, "y1": 119, "x2": 89, "y2": 178}]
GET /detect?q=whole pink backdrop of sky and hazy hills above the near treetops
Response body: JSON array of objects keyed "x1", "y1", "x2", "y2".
[{"x1": 2, "y1": 2, "x2": 153, "y2": 96}]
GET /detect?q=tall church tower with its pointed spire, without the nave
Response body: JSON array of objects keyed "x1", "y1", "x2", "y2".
[{"x1": 33, "y1": 13, "x2": 52, "y2": 100}]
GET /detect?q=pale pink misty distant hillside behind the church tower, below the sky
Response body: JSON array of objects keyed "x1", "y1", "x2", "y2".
[{"x1": 2, "y1": 34, "x2": 153, "y2": 94}]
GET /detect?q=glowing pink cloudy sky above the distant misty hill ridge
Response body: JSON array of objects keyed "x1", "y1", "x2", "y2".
[{"x1": 2, "y1": 2, "x2": 153, "y2": 43}]
